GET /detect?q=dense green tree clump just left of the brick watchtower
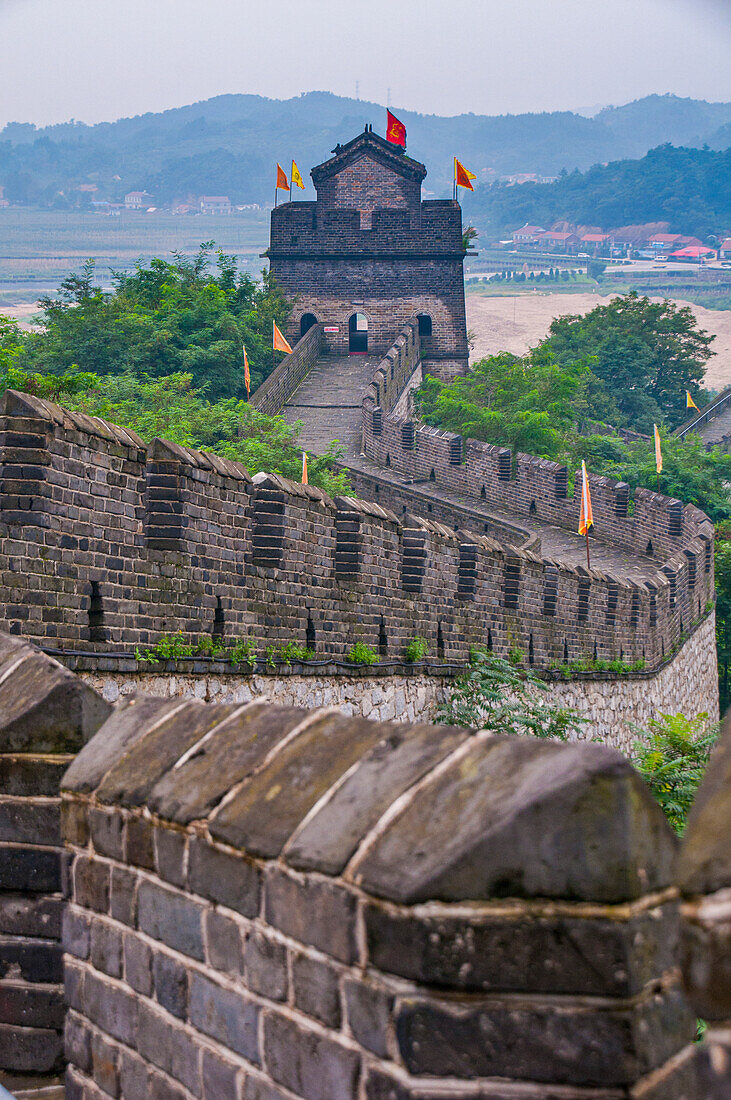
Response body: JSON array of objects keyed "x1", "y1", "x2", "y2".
[{"x1": 18, "y1": 242, "x2": 289, "y2": 400}]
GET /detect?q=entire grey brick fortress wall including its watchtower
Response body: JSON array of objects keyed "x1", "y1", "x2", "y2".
[{"x1": 0, "y1": 130, "x2": 731, "y2": 1100}]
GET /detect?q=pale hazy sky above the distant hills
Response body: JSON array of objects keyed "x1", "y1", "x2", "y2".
[{"x1": 0, "y1": 0, "x2": 731, "y2": 125}]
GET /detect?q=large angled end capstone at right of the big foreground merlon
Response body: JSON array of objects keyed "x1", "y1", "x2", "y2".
[{"x1": 348, "y1": 737, "x2": 677, "y2": 904}]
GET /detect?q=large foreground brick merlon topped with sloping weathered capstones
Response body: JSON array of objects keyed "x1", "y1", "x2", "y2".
[{"x1": 63, "y1": 695, "x2": 696, "y2": 1100}]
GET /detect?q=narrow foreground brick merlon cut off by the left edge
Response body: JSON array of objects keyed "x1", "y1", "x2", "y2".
[{"x1": 0, "y1": 633, "x2": 111, "y2": 1075}]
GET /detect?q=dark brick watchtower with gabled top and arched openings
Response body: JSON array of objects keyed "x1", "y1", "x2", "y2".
[{"x1": 267, "y1": 128, "x2": 468, "y2": 377}]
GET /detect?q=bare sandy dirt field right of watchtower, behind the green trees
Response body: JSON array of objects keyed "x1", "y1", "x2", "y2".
[{"x1": 467, "y1": 294, "x2": 731, "y2": 389}]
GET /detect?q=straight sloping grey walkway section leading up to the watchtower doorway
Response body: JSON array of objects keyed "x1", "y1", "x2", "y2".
[{"x1": 281, "y1": 355, "x2": 380, "y2": 454}]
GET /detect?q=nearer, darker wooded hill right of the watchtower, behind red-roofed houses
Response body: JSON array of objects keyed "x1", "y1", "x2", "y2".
[{"x1": 467, "y1": 145, "x2": 731, "y2": 240}]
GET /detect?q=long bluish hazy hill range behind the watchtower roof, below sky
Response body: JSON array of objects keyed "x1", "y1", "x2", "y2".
[{"x1": 0, "y1": 92, "x2": 731, "y2": 206}]
